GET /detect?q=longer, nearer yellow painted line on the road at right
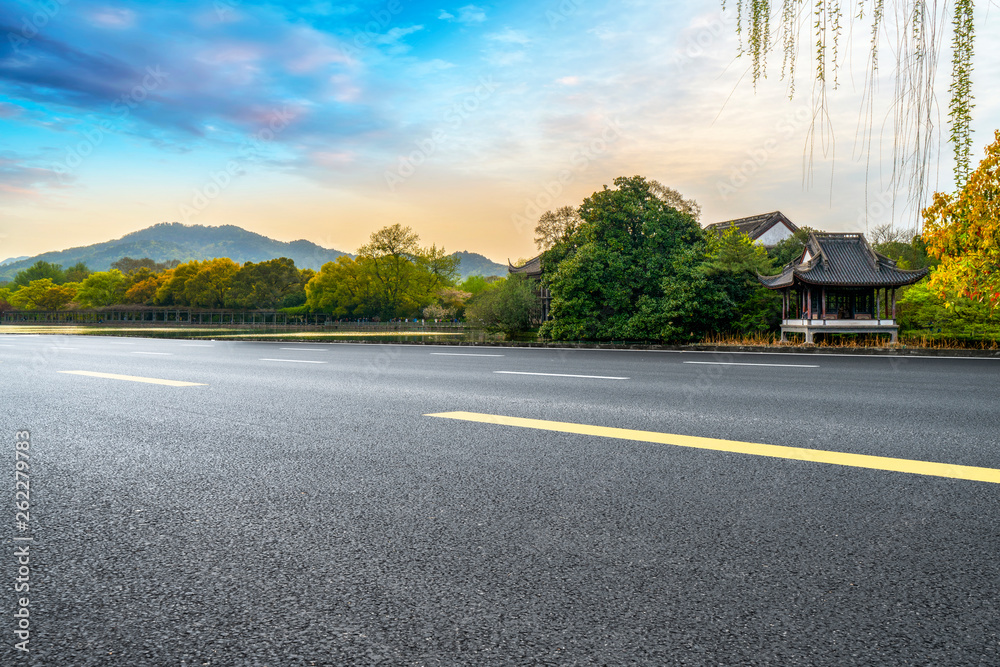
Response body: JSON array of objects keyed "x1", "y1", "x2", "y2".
[{"x1": 424, "y1": 412, "x2": 1000, "y2": 484}]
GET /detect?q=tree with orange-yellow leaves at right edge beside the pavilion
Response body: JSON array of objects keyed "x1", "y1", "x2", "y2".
[{"x1": 923, "y1": 130, "x2": 1000, "y2": 308}]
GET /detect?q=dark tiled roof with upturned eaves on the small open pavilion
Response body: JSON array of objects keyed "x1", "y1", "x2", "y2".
[{"x1": 759, "y1": 232, "x2": 928, "y2": 289}]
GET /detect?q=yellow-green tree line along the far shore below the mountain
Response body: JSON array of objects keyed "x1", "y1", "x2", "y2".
[{"x1": 0, "y1": 224, "x2": 502, "y2": 320}]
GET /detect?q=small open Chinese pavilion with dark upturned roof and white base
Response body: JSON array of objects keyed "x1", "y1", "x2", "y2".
[{"x1": 760, "y1": 232, "x2": 927, "y2": 343}]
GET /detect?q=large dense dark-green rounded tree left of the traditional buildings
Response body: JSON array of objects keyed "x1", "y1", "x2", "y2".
[{"x1": 541, "y1": 176, "x2": 705, "y2": 339}]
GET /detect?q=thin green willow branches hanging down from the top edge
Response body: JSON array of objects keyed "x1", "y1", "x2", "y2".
[{"x1": 722, "y1": 0, "x2": 975, "y2": 213}]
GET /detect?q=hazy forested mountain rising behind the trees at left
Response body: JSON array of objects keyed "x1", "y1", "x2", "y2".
[{"x1": 0, "y1": 222, "x2": 348, "y2": 282}]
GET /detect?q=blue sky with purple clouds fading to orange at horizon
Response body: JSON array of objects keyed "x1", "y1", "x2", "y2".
[{"x1": 0, "y1": 0, "x2": 1000, "y2": 262}]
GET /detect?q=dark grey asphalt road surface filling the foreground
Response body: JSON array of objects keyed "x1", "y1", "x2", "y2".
[{"x1": 0, "y1": 335, "x2": 1000, "y2": 666}]
